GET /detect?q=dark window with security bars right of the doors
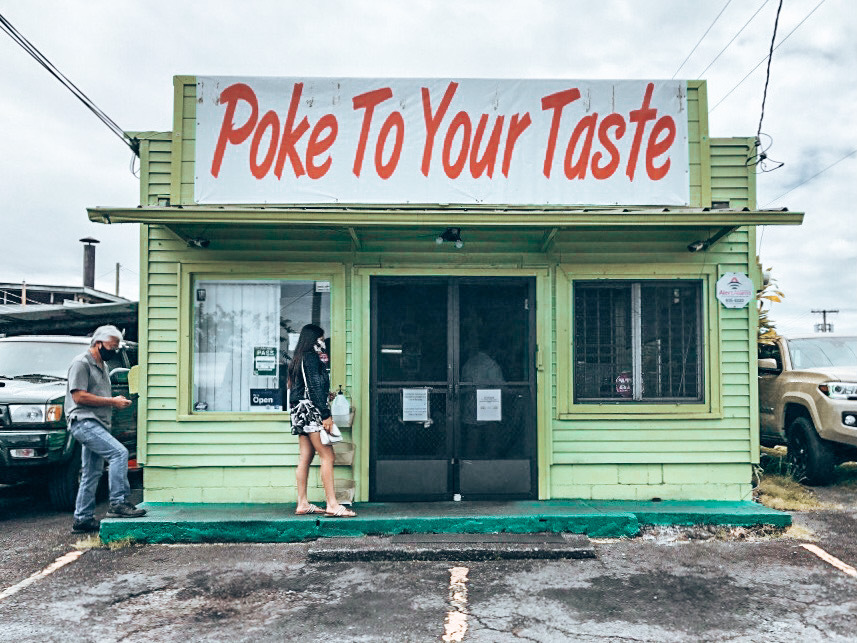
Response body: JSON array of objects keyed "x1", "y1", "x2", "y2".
[{"x1": 574, "y1": 280, "x2": 703, "y2": 403}]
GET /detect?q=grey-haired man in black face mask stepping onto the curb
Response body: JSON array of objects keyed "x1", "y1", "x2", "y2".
[{"x1": 65, "y1": 326, "x2": 146, "y2": 533}]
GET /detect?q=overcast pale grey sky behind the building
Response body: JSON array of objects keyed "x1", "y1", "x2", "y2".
[{"x1": 0, "y1": 0, "x2": 857, "y2": 334}]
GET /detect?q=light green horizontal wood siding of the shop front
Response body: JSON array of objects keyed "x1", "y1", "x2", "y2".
[{"x1": 130, "y1": 77, "x2": 758, "y2": 499}]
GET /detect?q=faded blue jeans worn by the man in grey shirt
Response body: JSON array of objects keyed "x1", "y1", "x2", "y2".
[{"x1": 69, "y1": 418, "x2": 131, "y2": 520}]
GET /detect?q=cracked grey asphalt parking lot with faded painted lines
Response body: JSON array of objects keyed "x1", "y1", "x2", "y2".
[{"x1": 0, "y1": 476, "x2": 857, "y2": 641}]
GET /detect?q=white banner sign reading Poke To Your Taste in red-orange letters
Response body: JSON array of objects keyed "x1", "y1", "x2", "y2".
[{"x1": 194, "y1": 77, "x2": 690, "y2": 205}]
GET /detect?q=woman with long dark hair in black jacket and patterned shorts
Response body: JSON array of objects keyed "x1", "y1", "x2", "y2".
[{"x1": 289, "y1": 324, "x2": 357, "y2": 518}]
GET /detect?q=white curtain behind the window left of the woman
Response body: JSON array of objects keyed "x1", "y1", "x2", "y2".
[{"x1": 193, "y1": 281, "x2": 280, "y2": 411}]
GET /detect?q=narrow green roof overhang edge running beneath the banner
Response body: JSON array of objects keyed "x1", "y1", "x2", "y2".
[{"x1": 87, "y1": 204, "x2": 804, "y2": 229}]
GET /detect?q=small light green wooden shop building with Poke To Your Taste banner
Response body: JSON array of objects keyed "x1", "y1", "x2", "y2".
[{"x1": 89, "y1": 76, "x2": 803, "y2": 503}]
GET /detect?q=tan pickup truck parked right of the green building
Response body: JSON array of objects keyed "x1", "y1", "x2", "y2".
[{"x1": 759, "y1": 335, "x2": 857, "y2": 485}]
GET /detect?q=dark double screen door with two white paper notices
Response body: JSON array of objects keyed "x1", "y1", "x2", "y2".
[{"x1": 369, "y1": 277, "x2": 537, "y2": 501}]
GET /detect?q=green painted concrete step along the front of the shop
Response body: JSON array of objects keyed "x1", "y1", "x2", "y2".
[{"x1": 95, "y1": 500, "x2": 791, "y2": 543}]
